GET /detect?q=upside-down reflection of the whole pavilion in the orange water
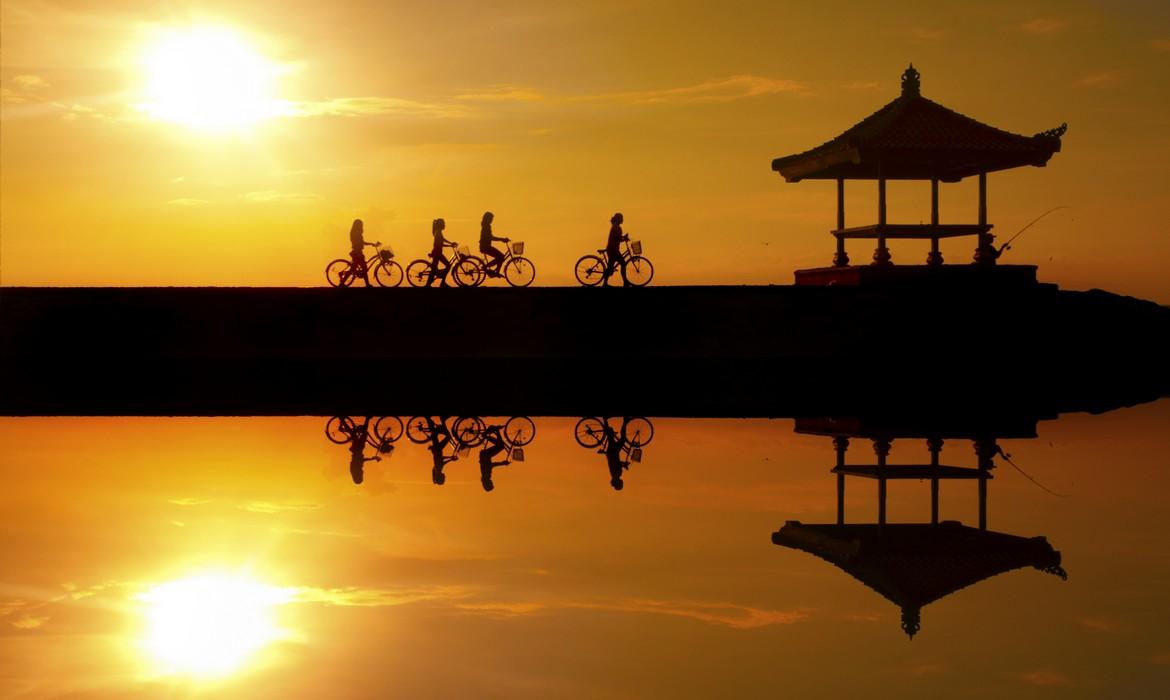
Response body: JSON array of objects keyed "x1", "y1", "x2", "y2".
[{"x1": 772, "y1": 419, "x2": 1066, "y2": 638}]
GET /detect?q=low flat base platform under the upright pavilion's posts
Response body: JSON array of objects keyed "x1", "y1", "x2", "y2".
[{"x1": 796, "y1": 265, "x2": 1040, "y2": 289}]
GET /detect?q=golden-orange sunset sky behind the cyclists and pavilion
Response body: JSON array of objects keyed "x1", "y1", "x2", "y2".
[{"x1": 0, "y1": 0, "x2": 1170, "y2": 302}]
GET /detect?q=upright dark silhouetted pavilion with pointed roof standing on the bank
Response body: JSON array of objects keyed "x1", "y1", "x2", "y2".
[{"x1": 772, "y1": 64, "x2": 1067, "y2": 284}]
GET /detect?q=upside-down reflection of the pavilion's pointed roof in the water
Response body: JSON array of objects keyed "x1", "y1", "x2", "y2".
[{"x1": 772, "y1": 521, "x2": 1065, "y2": 636}]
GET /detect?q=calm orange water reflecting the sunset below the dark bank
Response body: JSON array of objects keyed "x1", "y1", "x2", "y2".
[{"x1": 0, "y1": 400, "x2": 1170, "y2": 698}]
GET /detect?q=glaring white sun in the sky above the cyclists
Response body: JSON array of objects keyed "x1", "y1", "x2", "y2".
[{"x1": 138, "y1": 27, "x2": 281, "y2": 130}]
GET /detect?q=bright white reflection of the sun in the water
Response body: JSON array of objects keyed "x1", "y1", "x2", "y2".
[{"x1": 138, "y1": 575, "x2": 291, "y2": 677}]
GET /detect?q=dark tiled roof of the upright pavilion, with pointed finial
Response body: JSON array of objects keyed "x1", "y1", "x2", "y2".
[{"x1": 772, "y1": 64, "x2": 1067, "y2": 183}]
